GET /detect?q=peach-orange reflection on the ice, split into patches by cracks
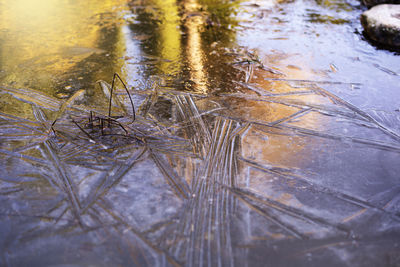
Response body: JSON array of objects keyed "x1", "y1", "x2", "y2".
[{"x1": 239, "y1": 55, "x2": 320, "y2": 174}]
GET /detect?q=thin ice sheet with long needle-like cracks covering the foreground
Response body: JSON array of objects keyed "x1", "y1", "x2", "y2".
[{"x1": 0, "y1": 63, "x2": 400, "y2": 266}]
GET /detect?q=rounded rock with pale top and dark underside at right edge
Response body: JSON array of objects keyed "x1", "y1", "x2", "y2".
[{"x1": 361, "y1": 5, "x2": 400, "y2": 47}]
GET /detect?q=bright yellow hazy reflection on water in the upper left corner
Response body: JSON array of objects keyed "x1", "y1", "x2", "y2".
[{"x1": 0, "y1": 0, "x2": 126, "y2": 90}]
